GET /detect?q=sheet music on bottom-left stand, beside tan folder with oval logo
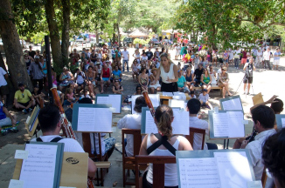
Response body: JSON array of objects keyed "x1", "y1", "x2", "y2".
[{"x1": 19, "y1": 144, "x2": 57, "y2": 188}]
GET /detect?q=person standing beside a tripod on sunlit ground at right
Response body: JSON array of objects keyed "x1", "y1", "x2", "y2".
[{"x1": 243, "y1": 57, "x2": 255, "y2": 95}]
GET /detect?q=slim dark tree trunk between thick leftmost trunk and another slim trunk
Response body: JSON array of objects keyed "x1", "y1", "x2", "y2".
[{"x1": 45, "y1": 0, "x2": 63, "y2": 73}]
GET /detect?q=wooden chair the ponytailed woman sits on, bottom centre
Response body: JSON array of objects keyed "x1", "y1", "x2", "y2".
[{"x1": 135, "y1": 155, "x2": 176, "y2": 188}]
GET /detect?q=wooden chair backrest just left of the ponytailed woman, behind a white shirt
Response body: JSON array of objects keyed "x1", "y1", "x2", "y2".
[{"x1": 122, "y1": 128, "x2": 142, "y2": 157}]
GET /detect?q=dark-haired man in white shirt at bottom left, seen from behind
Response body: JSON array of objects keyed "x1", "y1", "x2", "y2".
[{"x1": 31, "y1": 105, "x2": 96, "y2": 179}]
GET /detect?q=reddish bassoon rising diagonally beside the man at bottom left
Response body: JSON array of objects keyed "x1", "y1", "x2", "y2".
[{"x1": 50, "y1": 87, "x2": 94, "y2": 188}]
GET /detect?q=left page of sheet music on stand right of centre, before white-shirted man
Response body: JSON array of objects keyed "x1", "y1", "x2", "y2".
[{"x1": 213, "y1": 113, "x2": 229, "y2": 137}]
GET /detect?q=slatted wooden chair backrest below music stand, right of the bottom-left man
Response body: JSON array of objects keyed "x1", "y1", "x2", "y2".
[{"x1": 82, "y1": 133, "x2": 103, "y2": 161}]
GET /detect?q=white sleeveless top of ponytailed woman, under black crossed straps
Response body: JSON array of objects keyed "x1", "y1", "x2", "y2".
[{"x1": 146, "y1": 135, "x2": 180, "y2": 186}]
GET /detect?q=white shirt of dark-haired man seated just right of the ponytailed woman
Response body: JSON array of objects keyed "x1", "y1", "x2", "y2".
[{"x1": 189, "y1": 117, "x2": 209, "y2": 150}]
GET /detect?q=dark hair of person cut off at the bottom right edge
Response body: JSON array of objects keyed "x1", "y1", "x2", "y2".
[{"x1": 262, "y1": 128, "x2": 285, "y2": 187}]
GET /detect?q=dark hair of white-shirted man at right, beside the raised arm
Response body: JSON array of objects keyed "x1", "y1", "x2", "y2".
[{"x1": 251, "y1": 105, "x2": 275, "y2": 129}]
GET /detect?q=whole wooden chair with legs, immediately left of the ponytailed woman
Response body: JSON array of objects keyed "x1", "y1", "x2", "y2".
[{"x1": 122, "y1": 128, "x2": 142, "y2": 187}]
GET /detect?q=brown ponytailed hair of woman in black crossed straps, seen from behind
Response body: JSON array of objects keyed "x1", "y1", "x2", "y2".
[{"x1": 155, "y1": 105, "x2": 173, "y2": 140}]
